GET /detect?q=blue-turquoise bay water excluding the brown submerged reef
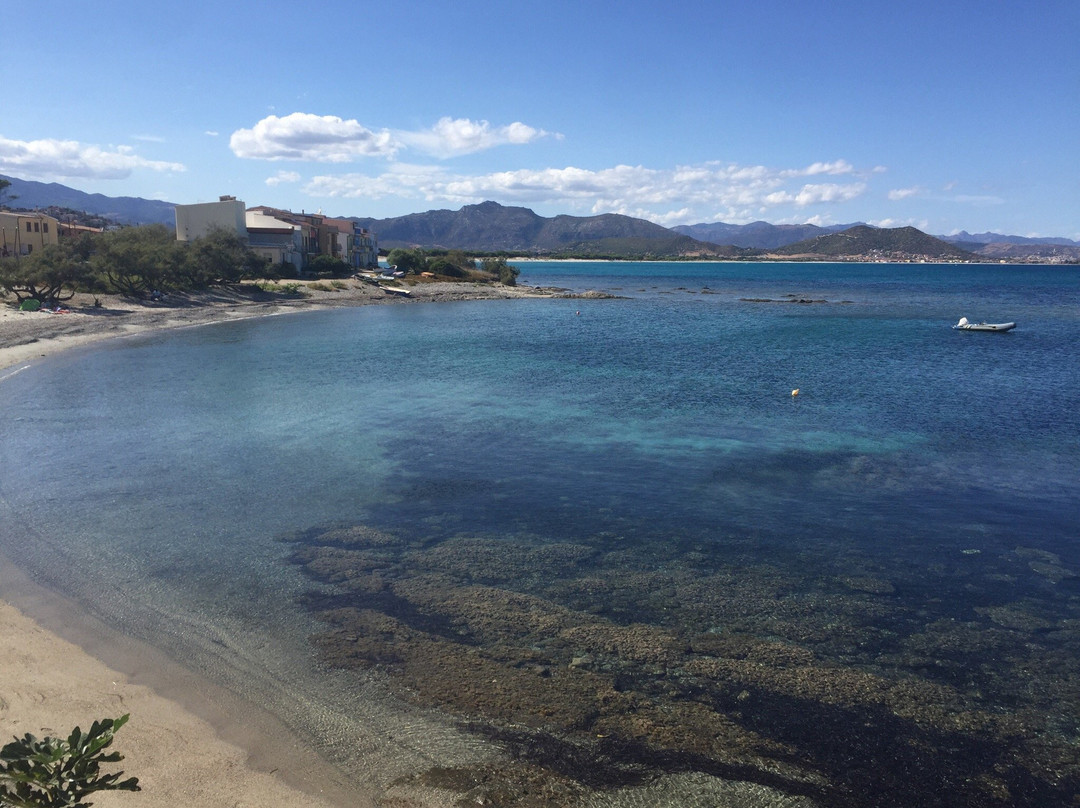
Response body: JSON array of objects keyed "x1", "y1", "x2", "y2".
[{"x1": 0, "y1": 262, "x2": 1080, "y2": 805}]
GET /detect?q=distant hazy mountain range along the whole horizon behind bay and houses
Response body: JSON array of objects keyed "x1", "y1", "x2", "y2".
[{"x1": 0, "y1": 175, "x2": 1080, "y2": 261}]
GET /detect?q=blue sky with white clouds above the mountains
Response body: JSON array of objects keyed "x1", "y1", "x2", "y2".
[{"x1": 0, "y1": 0, "x2": 1080, "y2": 239}]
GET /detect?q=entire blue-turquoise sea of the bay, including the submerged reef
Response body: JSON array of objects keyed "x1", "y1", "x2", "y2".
[{"x1": 0, "y1": 262, "x2": 1080, "y2": 808}]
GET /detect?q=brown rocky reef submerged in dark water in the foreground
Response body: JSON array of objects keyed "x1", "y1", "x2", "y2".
[{"x1": 286, "y1": 525, "x2": 1080, "y2": 808}]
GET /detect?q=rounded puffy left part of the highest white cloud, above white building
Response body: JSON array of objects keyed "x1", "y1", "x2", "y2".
[{"x1": 229, "y1": 112, "x2": 401, "y2": 163}]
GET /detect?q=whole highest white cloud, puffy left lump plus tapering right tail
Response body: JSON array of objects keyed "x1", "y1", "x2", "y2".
[{"x1": 229, "y1": 112, "x2": 562, "y2": 163}]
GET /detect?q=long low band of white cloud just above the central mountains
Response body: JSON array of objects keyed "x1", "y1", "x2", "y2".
[{"x1": 303, "y1": 161, "x2": 866, "y2": 225}]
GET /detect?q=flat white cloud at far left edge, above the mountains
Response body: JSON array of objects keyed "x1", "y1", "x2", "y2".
[{"x1": 0, "y1": 137, "x2": 187, "y2": 181}]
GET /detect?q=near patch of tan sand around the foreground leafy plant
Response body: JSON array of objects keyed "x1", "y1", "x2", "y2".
[{"x1": 0, "y1": 557, "x2": 375, "y2": 808}]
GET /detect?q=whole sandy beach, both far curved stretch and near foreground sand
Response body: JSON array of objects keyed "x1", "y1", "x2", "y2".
[{"x1": 0, "y1": 281, "x2": 551, "y2": 808}]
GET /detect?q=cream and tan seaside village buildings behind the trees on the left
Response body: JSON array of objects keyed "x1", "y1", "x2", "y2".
[{"x1": 0, "y1": 197, "x2": 379, "y2": 275}]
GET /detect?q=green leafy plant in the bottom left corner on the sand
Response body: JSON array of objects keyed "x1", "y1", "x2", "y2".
[{"x1": 0, "y1": 715, "x2": 140, "y2": 808}]
